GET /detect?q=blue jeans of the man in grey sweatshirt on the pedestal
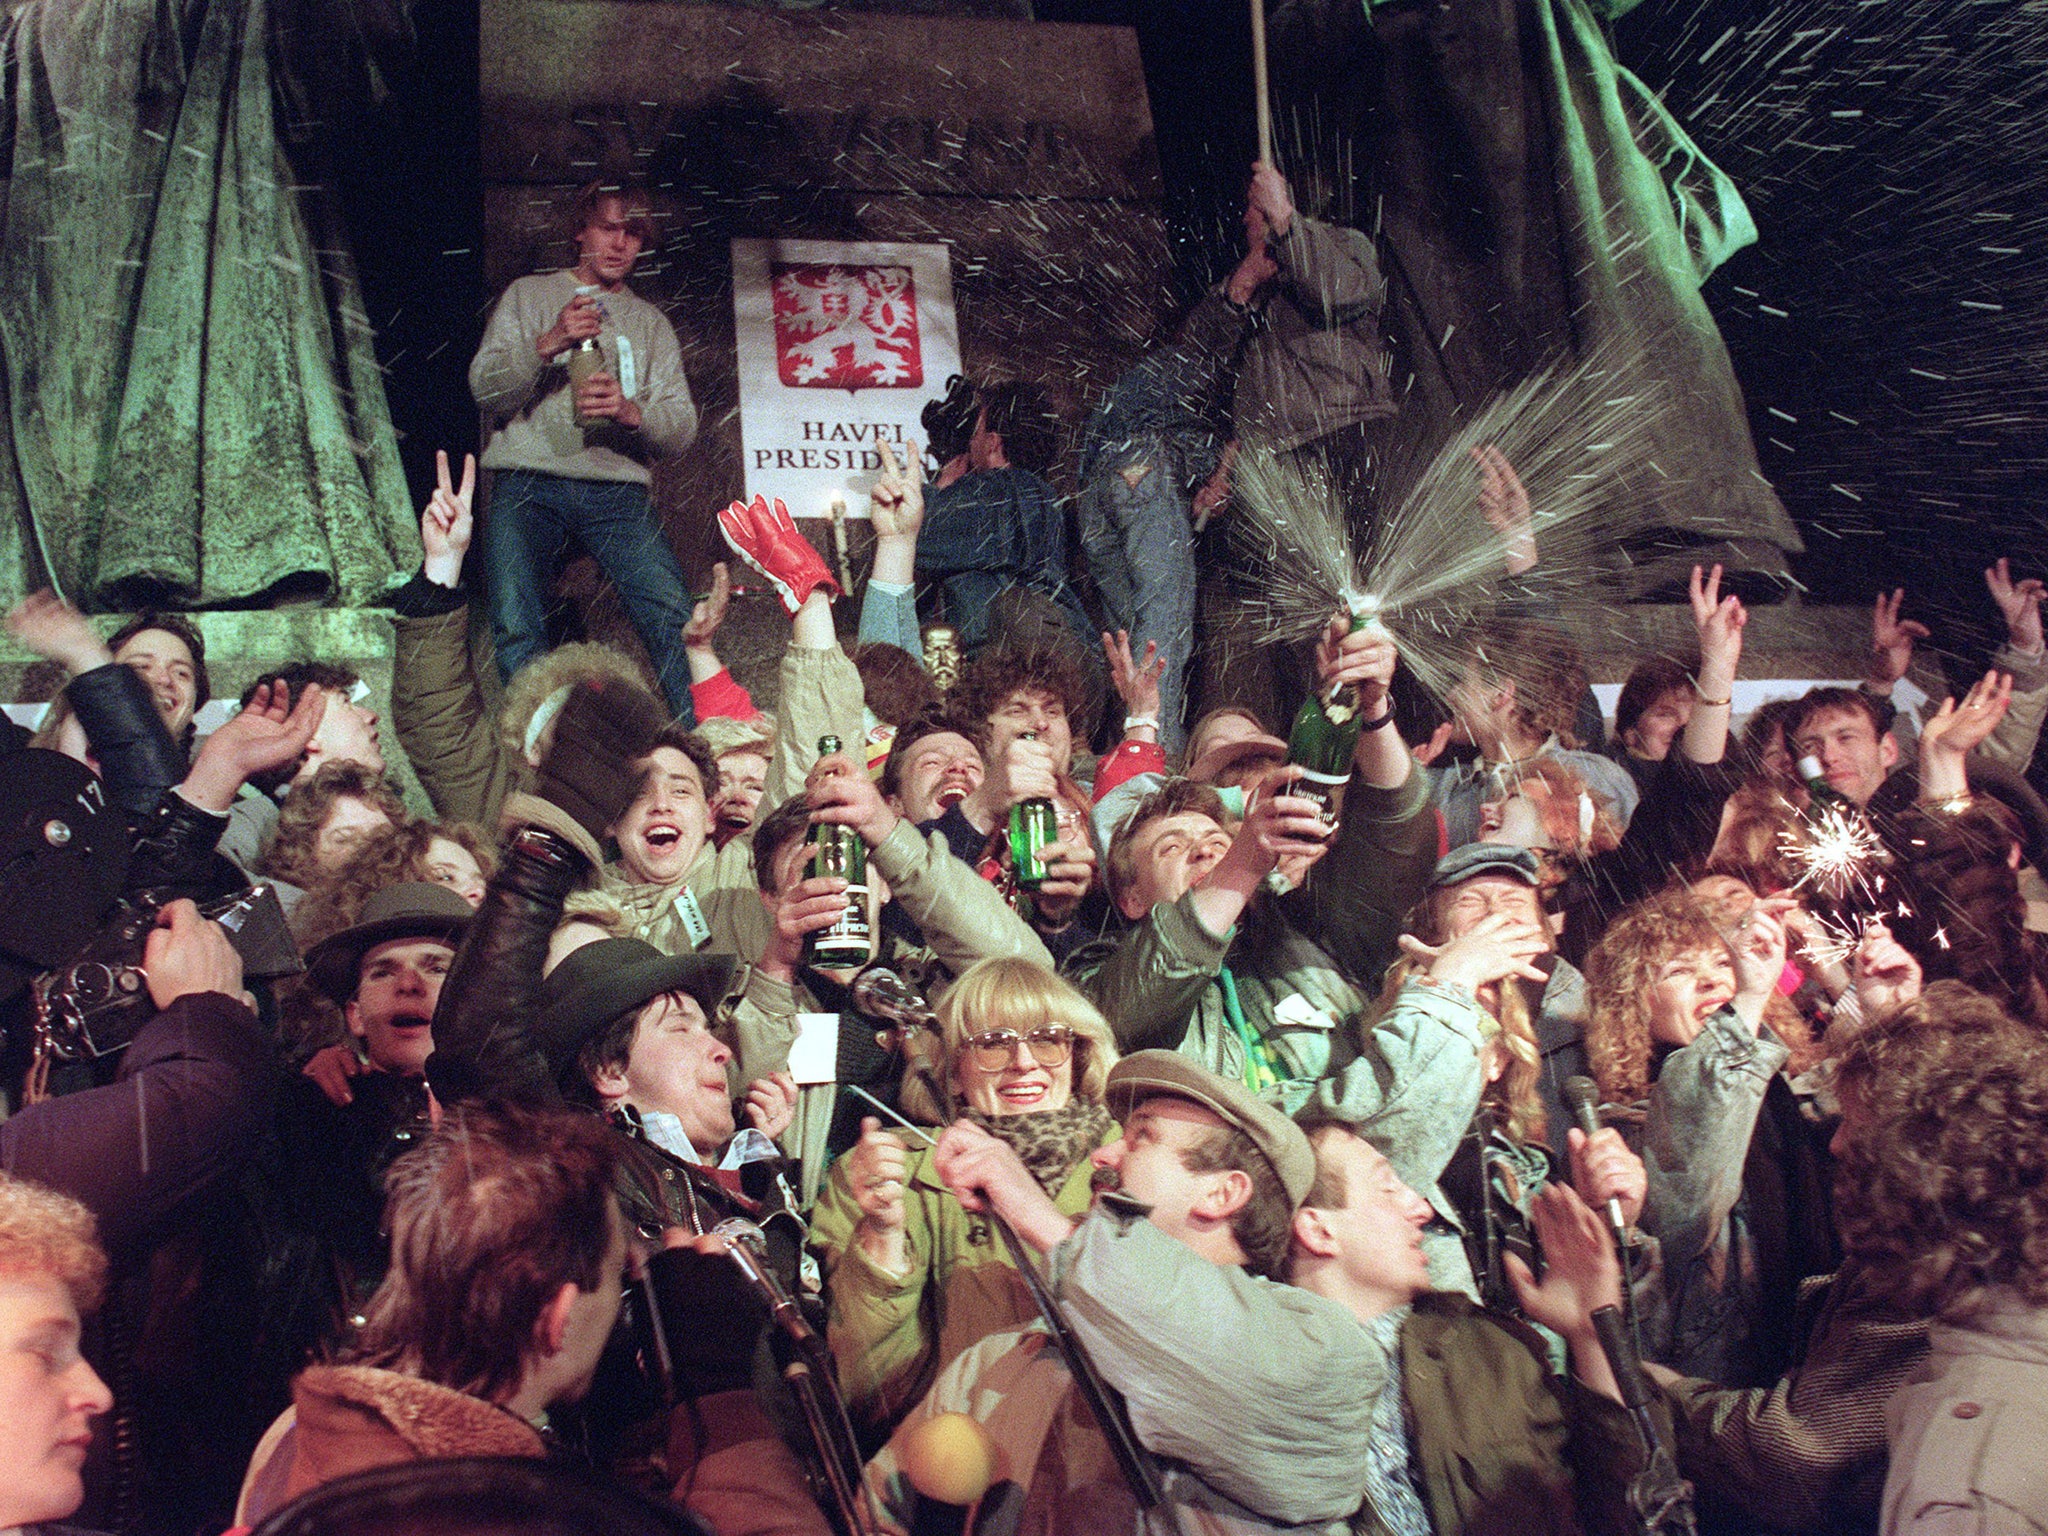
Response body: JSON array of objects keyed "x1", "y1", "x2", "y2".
[{"x1": 483, "y1": 469, "x2": 696, "y2": 725}]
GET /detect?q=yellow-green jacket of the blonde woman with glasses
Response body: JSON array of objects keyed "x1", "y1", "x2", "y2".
[{"x1": 811, "y1": 1128, "x2": 1120, "y2": 1430}]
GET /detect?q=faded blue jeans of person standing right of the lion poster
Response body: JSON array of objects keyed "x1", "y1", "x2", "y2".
[{"x1": 1079, "y1": 434, "x2": 1196, "y2": 754}]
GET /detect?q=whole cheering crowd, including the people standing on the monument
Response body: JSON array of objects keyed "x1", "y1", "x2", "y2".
[{"x1": 0, "y1": 166, "x2": 2048, "y2": 1536}]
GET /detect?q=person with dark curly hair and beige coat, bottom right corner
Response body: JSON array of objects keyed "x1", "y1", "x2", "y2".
[{"x1": 1835, "y1": 981, "x2": 2048, "y2": 1536}]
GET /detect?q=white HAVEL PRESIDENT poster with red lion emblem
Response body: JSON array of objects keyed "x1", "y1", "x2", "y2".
[{"x1": 733, "y1": 240, "x2": 961, "y2": 518}]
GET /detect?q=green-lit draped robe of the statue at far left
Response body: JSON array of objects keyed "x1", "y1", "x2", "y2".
[{"x1": 0, "y1": 0, "x2": 418, "y2": 608}]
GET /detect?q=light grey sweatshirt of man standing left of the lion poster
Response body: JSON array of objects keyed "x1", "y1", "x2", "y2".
[{"x1": 469, "y1": 270, "x2": 696, "y2": 485}]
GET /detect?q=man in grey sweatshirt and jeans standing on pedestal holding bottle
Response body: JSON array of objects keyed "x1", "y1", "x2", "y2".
[{"x1": 469, "y1": 182, "x2": 696, "y2": 725}]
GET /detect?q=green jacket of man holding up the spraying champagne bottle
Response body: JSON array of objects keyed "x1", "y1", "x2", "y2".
[{"x1": 1069, "y1": 774, "x2": 1438, "y2": 1110}]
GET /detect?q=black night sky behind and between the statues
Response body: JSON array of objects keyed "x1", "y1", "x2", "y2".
[{"x1": 326, "y1": 0, "x2": 2048, "y2": 679}]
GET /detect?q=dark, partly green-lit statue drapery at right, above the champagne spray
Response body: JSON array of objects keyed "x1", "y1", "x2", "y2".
[{"x1": 1272, "y1": 0, "x2": 1802, "y2": 569}]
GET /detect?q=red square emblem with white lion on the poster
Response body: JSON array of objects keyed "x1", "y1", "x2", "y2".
[{"x1": 770, "y1": 262, "x2": 924, "y2": 389}]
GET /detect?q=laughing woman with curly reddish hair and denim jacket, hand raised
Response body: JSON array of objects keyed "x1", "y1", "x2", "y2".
[{"x1": 1585, "y1": 891, "x2": 1839, "y2": 1386}]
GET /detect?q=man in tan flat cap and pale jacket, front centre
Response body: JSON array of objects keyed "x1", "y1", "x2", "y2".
[{"x1": 868, "y1": 1051, "x2": 1386, "y2": 1532}]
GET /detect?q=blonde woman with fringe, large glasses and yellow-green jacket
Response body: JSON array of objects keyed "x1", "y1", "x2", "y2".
[{"x1": 811, "y1": 958, "x2": 1116, "y2": 1436}]
